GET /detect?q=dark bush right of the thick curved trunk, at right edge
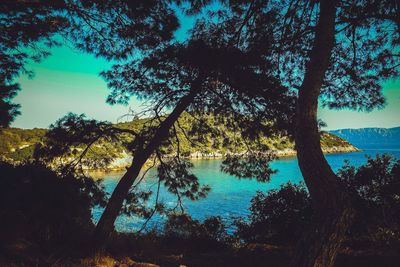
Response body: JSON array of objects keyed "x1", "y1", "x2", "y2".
[{"x1": 338, "y1": 155, "x2": 400, "y2": 247}]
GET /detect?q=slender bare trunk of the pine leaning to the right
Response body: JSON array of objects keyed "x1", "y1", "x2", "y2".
[{"x1": 93, "y1": 79, "x2": 201, "y2": 249}]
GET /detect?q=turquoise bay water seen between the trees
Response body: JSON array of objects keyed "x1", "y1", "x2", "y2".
[{"x1": 93, "y1": 146, "x2": 400, "y2": 232}]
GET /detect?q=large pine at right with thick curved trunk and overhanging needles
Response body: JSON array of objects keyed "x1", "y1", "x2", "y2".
[{"x1": 186, "y1": 1, "x2": 399, "y2": 266}]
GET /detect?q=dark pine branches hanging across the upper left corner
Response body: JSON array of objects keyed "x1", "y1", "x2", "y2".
[{"x1": 0, "y1": 0, "x2": 178, "y2": 127}]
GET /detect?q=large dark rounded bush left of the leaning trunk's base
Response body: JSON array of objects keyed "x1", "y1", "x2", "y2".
[{"x1": 0, "y1": 163, "x2": 105, "y2": 249}]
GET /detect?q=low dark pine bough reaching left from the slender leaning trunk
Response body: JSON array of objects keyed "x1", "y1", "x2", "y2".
[{"x1": 34, "y1": 113, "x2": 130, "y2": 169}]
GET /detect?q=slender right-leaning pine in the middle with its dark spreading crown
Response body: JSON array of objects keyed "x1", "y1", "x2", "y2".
[{"x1": 89, "y1": 31, "x2": 293, "y2": 247}]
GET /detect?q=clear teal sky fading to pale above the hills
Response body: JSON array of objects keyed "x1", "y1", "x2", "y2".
[{"x1": 12, "y1": 5, "x2": 400, "y2": 130}]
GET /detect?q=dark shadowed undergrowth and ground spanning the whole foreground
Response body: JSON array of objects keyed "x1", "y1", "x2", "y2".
[{"x1": 0, "y1": 155, "x2": 400, "y2": 267}]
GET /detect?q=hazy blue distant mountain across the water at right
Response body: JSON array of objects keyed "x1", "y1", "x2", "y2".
[{"x1": 329, "y1": 127, "x2": 400, "y2": 147}]
